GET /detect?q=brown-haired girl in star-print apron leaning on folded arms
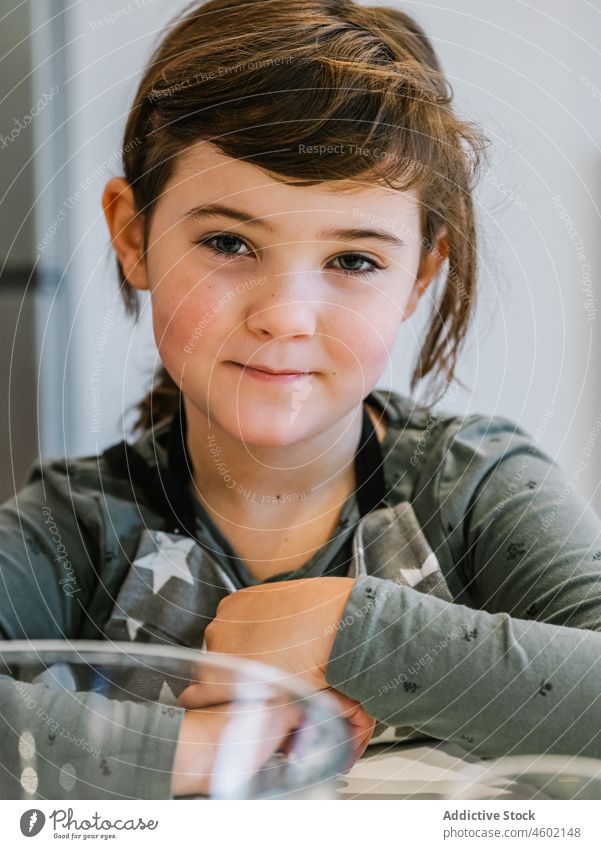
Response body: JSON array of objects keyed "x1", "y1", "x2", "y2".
[{"x1": 0, "y1": 0, "x2": 601, "y2": 797}]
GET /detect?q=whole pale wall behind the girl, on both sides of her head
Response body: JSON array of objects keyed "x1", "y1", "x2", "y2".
[{"x1": 34, "y1": 0, "x2": 601, "y2": 511}]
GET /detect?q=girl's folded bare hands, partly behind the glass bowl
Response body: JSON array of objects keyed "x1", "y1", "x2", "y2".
[{"x1": 173, "y1": 578, "x2": 375, "y2": 795}]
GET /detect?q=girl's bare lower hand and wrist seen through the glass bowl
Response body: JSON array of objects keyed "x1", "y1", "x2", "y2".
[{"x1": 171, "y1": 703, "x2": 302, "y2": 796}]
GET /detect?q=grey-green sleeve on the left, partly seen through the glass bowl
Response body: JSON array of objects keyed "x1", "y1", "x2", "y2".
[{"x1": 0, "y1": 461, "x2": 184, "y2": 799}]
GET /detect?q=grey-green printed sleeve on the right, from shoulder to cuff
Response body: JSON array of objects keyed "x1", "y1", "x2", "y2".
[{"x1": 326, "y1": 417, "x2": 601, "y2": 758}]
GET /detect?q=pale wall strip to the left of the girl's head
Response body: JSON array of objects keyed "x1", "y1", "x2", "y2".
[{"x1": 32, "y1": 0, "x2": 184, "y2": 456}]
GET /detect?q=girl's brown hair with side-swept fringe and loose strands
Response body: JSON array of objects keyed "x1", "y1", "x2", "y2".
[{"x1": 118, "y1": 0, "x2": 487, "y2": 429}]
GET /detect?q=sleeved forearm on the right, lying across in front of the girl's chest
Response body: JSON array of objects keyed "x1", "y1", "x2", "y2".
[{"x1": 326, "y1": 577, "x2": 601, "y2": 757}]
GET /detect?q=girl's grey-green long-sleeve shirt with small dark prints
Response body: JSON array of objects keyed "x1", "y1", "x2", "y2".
[{"x1": 0, "y1": 391, "x2": 601, "y2": 798}]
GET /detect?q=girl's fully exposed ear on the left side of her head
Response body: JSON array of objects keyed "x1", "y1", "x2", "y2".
[{"x1": 102, "y1": 177, "x2": 149, "y2": 289}]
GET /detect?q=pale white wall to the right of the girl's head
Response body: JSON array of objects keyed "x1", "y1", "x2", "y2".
[{"x1": 390, "y1": 0, "x2": 601, "y2": 510}]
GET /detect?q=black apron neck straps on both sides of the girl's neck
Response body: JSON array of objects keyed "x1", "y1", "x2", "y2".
[{"x1": 103, "y1": 393, "x2": 388, "y2": 538}]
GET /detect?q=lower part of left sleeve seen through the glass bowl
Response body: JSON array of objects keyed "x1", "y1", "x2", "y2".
[{"x1": 0, "y1": 676, "x2": 185, "y2": 799}]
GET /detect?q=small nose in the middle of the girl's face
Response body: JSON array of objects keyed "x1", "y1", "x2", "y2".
[{"x1": 246, "y1": 271, "x2": 319, "y2": 338}]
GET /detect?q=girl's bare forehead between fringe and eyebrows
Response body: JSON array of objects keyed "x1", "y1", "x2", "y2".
[{"x1": 164, "y1": 142, "x2": 419, "y2": 224}]
